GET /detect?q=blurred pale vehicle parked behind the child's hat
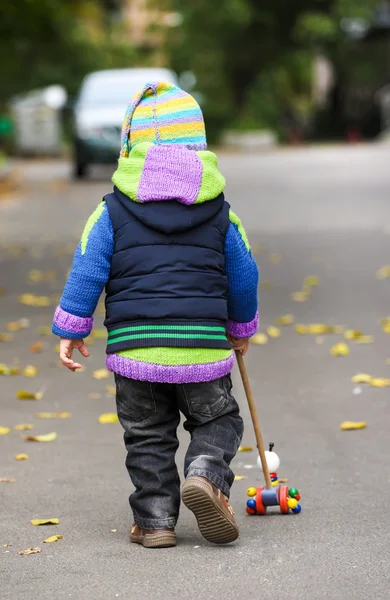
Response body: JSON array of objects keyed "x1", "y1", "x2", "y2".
[{"x1": 72, "y1": 68, "x2": 178, "y2": 178}]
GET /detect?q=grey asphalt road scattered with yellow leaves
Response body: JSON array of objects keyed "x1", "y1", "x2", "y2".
[{"x1": 0, "y1": 146, "x2": 390, "y2": 600}]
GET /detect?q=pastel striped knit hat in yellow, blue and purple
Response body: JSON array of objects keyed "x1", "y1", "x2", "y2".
[{"x1": 120, "y1": 81, "x2": 207, "y2": 157}]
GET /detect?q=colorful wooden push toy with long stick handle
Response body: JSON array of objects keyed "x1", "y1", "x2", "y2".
[{"x1": 236, "y1": 351, "x2": 302, "y2": 515}]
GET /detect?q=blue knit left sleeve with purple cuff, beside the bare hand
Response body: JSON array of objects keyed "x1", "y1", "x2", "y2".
[{"x1": 52, "y1": 202, "x2": 114, "y2": 338}]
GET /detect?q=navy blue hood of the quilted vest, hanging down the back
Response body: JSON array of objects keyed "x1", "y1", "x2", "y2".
[{"x1": 114, "y1": 187, "x2": 224, "y2": 233}]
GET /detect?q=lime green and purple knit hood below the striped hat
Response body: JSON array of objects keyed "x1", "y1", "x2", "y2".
[{"x1": 112, "y1": 142, "x2": 225, "y2": 211}]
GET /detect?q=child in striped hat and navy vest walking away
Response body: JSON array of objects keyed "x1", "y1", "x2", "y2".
[{"x1": 53, "y1": 82, "x2": 258, "y2": 548}]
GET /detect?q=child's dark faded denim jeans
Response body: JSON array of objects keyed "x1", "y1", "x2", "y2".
[{"x1": 115, "y1": 375, "x2": 243, "y2": 529}]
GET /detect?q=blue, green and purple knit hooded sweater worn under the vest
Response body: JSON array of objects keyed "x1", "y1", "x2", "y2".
[{"x1": 53, "y1": 143, "x2": 258, "y2": 383}]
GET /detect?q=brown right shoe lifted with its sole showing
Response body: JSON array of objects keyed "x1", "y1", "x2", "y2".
[{"x1": 182, "y1": 476, "x2": 240, "y2": 544}]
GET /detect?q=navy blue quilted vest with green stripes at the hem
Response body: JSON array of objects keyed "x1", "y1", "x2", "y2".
[{"x1": 104, "y1": 188, "x2": 231, "y2": 353}]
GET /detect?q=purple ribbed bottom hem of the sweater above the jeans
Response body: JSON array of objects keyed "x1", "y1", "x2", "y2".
[{"x1": 106, "y1": 353, "x2": 234, "y2": 383}]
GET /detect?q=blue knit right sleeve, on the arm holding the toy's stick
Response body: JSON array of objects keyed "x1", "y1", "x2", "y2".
[{"x1": 225, "y1": 210, "x2": 259, "y2": 337}]
